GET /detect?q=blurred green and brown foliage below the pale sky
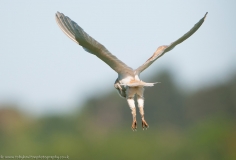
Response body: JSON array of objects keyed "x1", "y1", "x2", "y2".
[{"x1": 0, "y1": 72, "x2": 236, "y2": 160}]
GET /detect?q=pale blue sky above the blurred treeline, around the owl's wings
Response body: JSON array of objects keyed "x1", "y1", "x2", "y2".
[{"x1": 0, "y1": 0, "x2": 236, "y2": 114}]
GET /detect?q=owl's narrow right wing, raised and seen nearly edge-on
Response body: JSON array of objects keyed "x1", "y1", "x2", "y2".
[{"x1": 135, "y1": 13, "x2": 207, "y2": 75}]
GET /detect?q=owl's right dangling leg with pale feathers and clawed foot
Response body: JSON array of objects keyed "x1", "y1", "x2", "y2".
[{"x1": 137, "y1": 88, "x2": 149, "y2": 129}]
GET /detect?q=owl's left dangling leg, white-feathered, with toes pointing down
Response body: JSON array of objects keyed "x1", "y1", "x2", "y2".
[{"x1": 126, "y1": 88, "x2": 137, "y2": 131}]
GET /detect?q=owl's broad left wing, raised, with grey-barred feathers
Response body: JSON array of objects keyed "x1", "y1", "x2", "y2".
[{"x1": 56, "y1": 12, "x2": 134, "y2": 75}]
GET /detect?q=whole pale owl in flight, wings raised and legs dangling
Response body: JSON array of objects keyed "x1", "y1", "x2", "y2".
[{"x1": 56, "y1": 12, "x2": 207, "y2": 130}]
